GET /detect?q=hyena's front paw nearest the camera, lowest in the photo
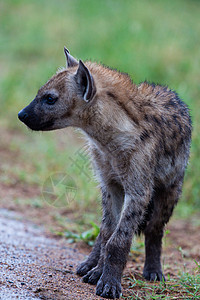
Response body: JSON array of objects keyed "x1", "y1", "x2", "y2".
[{"x1": 96, "y1": 274, "x2": 122, "y2": 299}]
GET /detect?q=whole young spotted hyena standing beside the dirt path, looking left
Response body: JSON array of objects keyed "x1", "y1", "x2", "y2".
[{"x1": 18, "y1": 48, "x2": 191, "y2": 298}]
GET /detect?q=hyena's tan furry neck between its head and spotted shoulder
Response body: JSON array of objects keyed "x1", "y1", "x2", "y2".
[{"x1": 76, "y1": 62, "x2": 139, "y2": 153}]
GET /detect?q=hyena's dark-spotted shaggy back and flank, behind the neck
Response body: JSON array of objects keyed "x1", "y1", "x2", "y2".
[{"x1": 125, "y1": 82, "x2": 192, "y2": 187}]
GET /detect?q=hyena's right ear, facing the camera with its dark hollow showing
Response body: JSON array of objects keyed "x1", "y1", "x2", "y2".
[{"x1": 75, "y1": 60, "x2": 96, "y2": 102}]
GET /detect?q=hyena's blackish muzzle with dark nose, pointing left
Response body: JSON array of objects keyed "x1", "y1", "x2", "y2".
[{"x1": 18, "y1": 99, "x2": 54, "y2": 131}]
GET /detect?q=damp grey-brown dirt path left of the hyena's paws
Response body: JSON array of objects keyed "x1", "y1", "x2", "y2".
[{"x1": 0, "y1": 209, "x2": 99, "y2": 300}]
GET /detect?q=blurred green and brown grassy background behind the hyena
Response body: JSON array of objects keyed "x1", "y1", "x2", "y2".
[{"x1": 0, "y1": 0, "x2": 200, "y2": 227}]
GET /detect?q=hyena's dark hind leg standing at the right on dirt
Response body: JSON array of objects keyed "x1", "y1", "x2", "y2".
[{"x1": 143, "y1": 181, "x2": 182, "y2": 281}]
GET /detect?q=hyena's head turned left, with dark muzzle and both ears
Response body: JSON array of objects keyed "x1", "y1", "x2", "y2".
[{"x1": 18, "y1": 48, "x2": 96, "y2": 130}]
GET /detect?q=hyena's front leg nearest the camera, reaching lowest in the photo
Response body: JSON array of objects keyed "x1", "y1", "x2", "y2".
[{"x1": 96, "y1": 192, "x2": 148, "y2": 299}]
